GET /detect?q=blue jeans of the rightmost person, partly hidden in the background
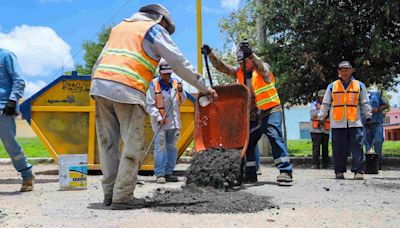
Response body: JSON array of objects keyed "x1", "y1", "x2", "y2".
[{"x1": 365, "y1": 122, "x2": 384, "y2": 161}]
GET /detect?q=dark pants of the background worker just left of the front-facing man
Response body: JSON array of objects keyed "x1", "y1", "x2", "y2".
[{"x1": 311, "y1": 133, "x2": 329, "y2": 167}]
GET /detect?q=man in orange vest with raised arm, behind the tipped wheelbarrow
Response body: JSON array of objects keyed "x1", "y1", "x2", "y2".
[{"x1": 203, "y1": 40, "x2": 292, "y2": 183}]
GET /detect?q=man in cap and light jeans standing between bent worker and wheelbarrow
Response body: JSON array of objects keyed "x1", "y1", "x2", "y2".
[{"x1": 146, "y1": 61, "x2": 186, "y2": 184}]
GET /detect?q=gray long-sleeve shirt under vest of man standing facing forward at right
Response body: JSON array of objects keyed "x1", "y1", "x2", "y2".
[{"x1": 318, "y1": 77, "x2": 372, "y2": 128}]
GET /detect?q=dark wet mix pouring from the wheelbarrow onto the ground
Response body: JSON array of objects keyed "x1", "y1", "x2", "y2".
[{"x1": 151, "y1": 149, "x2": 276, "y2": 214}]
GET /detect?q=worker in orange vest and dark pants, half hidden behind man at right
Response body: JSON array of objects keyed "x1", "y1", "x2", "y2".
[{"x1": 310, "y1": 89, "x2": 331, "y2": 169}]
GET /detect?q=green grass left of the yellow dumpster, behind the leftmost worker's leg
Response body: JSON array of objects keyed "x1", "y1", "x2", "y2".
[{"x1": 0, "y1": 138, "x2": 51, "y2": 158}]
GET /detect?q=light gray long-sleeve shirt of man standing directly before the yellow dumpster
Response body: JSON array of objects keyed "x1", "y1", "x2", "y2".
[{"x1": 146, "y1": 76, "x2": 187, "y2": 131}]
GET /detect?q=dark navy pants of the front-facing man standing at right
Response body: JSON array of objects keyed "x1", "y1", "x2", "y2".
[{"x1": 332, "y1": 127, "x2": 365, "y2": 173}]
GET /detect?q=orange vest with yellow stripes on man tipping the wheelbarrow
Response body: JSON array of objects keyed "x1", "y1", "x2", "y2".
[{"x1": 236, "y1": 67, "x2": 281, "y2": 110}]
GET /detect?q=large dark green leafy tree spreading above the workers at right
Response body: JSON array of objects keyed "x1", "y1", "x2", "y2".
[{"x1": 220, "y1": 0, "x2": 400, "y2": 105}]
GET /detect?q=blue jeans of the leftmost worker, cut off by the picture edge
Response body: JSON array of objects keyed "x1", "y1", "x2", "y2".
[{"x1": 0, "y1": 115, "x2": 32, "y2": 179}]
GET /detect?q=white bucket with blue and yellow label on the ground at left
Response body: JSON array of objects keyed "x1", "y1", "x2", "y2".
[{"x1": 58, "y1": 154, "x2": 88, "y2": 190}]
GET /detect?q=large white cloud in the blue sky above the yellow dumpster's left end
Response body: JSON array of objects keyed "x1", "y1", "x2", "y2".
[{"x1": 0, "y1": 25, "x2": 74, "y2": 77}]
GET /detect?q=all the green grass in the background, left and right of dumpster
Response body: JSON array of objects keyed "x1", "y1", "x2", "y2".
[{"x1": 0, "y1": 138, "x2": 400, "y2": 158}]
